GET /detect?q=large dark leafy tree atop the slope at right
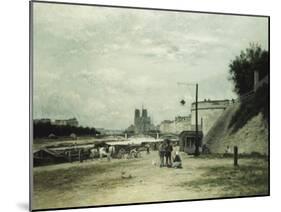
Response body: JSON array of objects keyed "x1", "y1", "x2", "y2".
[{"x1": 229, "y1": 44, "x2": 269, "y2": 95}]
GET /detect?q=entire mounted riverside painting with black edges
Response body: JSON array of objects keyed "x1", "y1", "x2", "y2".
[{"x1": 30, "y1": 1, "x2": 269, "y2": 210}]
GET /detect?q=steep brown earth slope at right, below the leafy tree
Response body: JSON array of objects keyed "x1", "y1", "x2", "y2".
[{"x1": 204, "y1": 100, "x2": 268, "y2": 155}]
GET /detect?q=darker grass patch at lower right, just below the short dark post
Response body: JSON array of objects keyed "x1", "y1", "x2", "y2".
[{"x1": 179, "y1": 160, "x2": 269, "y2": 197}]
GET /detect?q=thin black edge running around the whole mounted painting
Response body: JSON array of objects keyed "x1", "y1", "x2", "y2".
[{"x1": 29, "y1": 0, "x2": 270, "y2": 211}]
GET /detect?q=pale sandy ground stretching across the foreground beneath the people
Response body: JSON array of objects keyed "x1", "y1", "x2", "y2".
[{"x1": 33, "y1": 152, "x2": 267, "y2": 209}]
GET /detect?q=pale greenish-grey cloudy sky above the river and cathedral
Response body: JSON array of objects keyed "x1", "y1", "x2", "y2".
[{"x1": 33, "y1": 3, "x2": 268, "y2": 129}]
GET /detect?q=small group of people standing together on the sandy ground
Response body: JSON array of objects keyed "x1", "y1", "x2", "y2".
[{"x1": 159, "y1": 139, "x2": 182, "y2": 168}]
